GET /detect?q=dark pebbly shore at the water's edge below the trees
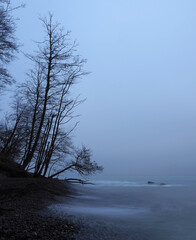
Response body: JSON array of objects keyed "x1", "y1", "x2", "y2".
[{"x1": 0, "y1": 175, "x2": 79, "y2": 240}]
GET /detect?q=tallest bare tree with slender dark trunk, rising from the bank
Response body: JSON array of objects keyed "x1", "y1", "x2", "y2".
[{"x1": 20, "y1": 15, "x2": 85, "y2": 168}]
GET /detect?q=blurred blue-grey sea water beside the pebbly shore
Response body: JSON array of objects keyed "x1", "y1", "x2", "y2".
[{"x1": 50, "y1": 177, "x2": 196, "y2": 240}]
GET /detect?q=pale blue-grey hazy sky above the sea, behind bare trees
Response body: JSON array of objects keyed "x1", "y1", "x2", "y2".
[{"x1": 5, "y1": 0, "x2": 196, "y2": 176}]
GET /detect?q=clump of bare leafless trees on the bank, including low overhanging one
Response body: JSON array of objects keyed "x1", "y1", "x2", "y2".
[{"x1": 2, "y1": 14, "x2": 102, "y2": 177}]
